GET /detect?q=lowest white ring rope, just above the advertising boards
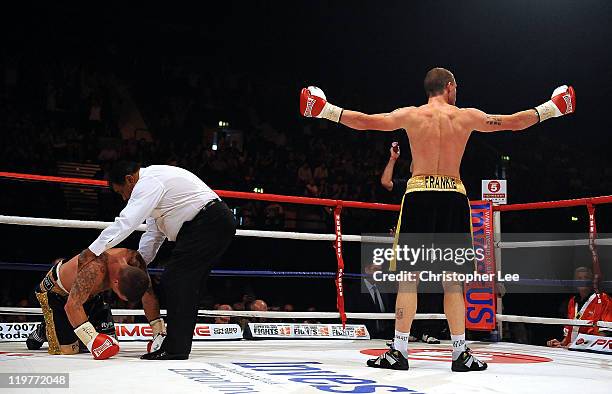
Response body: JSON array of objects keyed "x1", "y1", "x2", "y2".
[{"x1": 0, "y1": 307, "x2": 612, "y2": 329}]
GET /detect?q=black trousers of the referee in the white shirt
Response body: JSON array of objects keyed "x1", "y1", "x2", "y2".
[{"x1": 162, "y1": 202, "x2": 236, "y2": 354}]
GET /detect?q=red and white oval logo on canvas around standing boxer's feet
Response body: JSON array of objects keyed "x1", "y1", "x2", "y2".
[{"x1": 360, "y1": 348, "x2": 553, "y2": 364}]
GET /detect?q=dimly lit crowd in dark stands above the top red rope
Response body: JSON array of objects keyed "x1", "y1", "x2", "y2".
[{"x1": 0, "y1": 58, "x2": 612, "y2": 209}]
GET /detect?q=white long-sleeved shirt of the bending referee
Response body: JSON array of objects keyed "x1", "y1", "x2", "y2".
[{"x1": 89, "y1": 166, "x2": 219, "y2": 264}]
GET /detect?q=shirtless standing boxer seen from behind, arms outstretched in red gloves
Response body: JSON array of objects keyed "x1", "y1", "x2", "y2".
[{"x1": 300, "y1": 68, "x2": 576, "y2": 372}]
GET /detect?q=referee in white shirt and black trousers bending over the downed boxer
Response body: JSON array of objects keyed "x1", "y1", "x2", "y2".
[{"x1": 79, "y1": 161, "x2": 236, "y2": 360}]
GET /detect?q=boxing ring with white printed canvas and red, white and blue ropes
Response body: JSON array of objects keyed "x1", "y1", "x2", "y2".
[{"x1": 0, "y1": 173, "x2": 612, "y2": 393}]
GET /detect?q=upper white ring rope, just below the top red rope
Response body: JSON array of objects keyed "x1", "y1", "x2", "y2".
[{"x1": 0, "y1": 215, "x2": 612, "y2": 249}]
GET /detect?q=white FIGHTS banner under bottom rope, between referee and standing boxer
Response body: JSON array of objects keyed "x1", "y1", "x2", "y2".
[{"x1": 248, "y1": 323, "x2": 370, "y2": 339}]
